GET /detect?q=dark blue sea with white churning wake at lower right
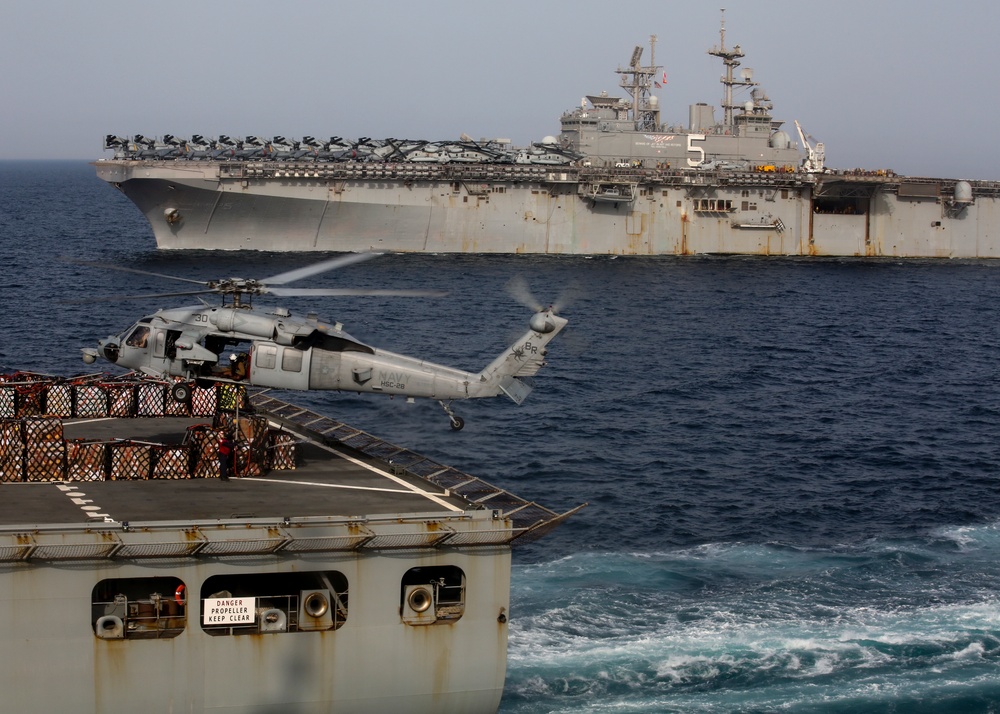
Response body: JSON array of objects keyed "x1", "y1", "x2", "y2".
[{"x1": 0, "y1": 162, "x2": 1000, "y2": 714}]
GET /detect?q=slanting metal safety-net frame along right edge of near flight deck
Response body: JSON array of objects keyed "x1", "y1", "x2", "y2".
[{"x1": 250, "y1": 392, "x2": 587, "y2": 543}]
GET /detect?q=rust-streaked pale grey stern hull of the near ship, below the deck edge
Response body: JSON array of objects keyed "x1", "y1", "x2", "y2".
[{"x1": 0, "y1": 544, "x2": 510, "y2": 714}]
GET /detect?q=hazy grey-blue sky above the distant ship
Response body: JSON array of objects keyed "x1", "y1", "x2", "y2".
[{"x1": 0, "y1": 0, "x2": 1000, "y2": 180}]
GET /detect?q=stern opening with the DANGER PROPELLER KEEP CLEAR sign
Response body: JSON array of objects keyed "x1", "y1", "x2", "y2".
[{"x1": 199, "y1": 570, "x2": 347, "y2": 637}]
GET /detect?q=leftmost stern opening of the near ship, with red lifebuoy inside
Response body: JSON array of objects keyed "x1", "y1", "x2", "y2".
[{"x1": 90, "y1": 577, "x2": 187, "y2": 640}]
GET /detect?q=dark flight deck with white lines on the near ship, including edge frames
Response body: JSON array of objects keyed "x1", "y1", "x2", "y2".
[{"x1": 0, "y1": 386, "x2": 576, "y2": 560}]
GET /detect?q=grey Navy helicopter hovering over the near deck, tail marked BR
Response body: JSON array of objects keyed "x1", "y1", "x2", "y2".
[{"x1": 74, "y1": 253, "x2": 567, "y2": 431}]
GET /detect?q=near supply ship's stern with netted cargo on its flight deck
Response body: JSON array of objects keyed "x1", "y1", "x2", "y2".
[{"x1": 0, "y1": 374, "x2": 569, "y2": 714}]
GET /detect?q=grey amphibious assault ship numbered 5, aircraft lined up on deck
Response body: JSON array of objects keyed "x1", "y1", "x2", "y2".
[{"x1": 95, "y1": 17, "x2": 1000, "y2": 258}]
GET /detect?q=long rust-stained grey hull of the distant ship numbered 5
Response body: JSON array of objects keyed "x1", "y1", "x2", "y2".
[{"x1": 96, "y1": 160, "x2": 1000, "y2": 258}]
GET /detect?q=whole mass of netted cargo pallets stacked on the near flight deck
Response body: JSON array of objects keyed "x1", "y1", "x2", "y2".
[{"x1": 0, "y1": 372, "x2": 295, "y2": 482}]
